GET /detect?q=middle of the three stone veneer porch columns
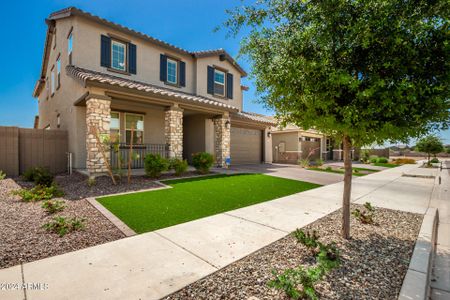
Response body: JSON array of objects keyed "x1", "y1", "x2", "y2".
[{"x1": 164, "y1": 106, "x2": 183, "y2": 158}]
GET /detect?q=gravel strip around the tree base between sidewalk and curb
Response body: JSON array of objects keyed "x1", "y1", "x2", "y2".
[{"x1": 165, "y1": 205, "x2": 423, "y2": 300}]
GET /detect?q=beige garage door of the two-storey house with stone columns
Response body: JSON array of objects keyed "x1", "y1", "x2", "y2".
[{"x1": 231, "y1": 127, "x2": 262, "y2": 165}]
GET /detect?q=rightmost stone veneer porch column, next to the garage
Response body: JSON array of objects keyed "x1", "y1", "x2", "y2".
[{"x1": 214, "y1": 116, "x2": 231, "y2": 167}]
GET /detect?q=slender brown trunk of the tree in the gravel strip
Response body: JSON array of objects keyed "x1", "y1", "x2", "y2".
[{"x1": 342, "y1": 135, "x2": 352, "y2": 239}]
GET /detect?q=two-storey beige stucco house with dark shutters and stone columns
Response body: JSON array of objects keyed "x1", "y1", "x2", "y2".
[{"x1": 33, "y1": 7, "x2": 275, "y2": 175}]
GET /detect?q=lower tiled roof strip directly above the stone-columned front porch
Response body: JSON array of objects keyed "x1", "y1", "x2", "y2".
[{"x1": 66, "y1": 65, "x2": 239, "y2": 111}]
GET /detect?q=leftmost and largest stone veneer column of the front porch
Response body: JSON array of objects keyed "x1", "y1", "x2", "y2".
[{"x1": 86, "y1": 95, "x2": 111, "y2": 176}]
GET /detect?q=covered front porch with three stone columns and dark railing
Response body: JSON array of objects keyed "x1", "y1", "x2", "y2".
[{"x1": 78, "y1": 90, "x2": 231, "y2": 176}]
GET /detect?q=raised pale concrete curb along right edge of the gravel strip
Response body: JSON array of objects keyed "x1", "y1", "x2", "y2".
[{"x1": 398, "y1": 207, "x2": 439, "y2": 300}]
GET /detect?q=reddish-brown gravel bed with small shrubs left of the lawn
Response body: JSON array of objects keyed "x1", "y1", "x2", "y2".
[{"x1": 0, "y1": 175, "x2": 124, "y2": 268}]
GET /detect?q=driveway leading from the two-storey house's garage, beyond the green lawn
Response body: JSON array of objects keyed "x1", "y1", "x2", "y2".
[{"x1": 229, "y1": 164, "x2": 344, "y2": 185}]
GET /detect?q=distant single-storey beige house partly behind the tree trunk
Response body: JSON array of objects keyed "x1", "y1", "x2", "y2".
[{"x1": 271, "y1": 124, "x2": 359, "y2": 164}]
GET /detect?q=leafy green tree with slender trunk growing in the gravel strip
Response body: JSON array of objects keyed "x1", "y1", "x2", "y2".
[{"x1": 224, "y1": 0, "x2": 450, "y2": 238}]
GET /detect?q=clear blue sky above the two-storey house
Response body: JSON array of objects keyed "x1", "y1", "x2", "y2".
[{"x1": 0, "y1": 0, "x2": 450, "y2": 143}]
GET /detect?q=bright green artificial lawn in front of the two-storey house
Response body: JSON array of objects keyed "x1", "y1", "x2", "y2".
[{"x1": 97, "y1": 174, "x2": 320, "y2": 233}]
